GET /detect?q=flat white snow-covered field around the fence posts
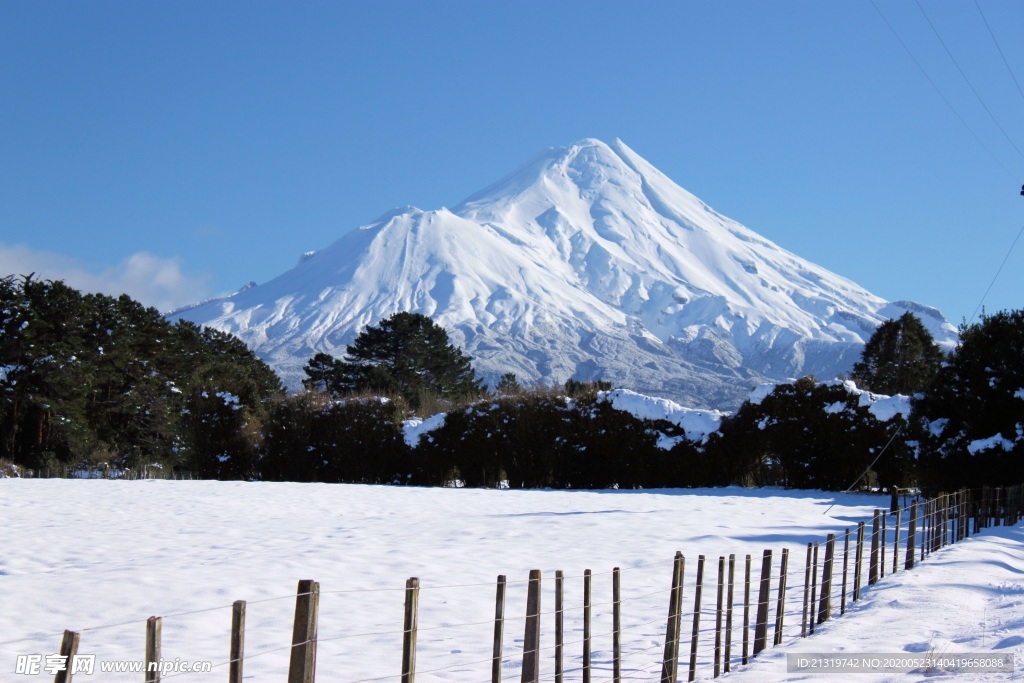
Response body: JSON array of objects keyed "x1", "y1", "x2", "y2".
[{"x1": 0, "y1": 479, "x2": 1024, "y2": 683}]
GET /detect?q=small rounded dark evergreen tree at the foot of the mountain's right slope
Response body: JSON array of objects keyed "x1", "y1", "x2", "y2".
[{"x1": 852, "y1": 312, "x2": 944, "y2": 396}]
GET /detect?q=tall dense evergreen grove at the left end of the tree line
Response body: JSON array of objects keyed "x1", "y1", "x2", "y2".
[{"x1": 0, "y1": 275, "x2": 281, "y2": 476}]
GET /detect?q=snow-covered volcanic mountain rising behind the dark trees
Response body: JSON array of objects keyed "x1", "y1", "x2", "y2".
[{"x1": 172, "y1": 139, "x2": 956, "y2": 408}]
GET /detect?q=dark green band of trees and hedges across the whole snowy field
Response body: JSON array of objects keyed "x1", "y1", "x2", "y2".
[{"x1": 0, "y1": 276, "x2": 1024, "y2": 490}]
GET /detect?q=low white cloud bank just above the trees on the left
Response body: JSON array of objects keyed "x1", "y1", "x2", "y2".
[{"x1": 0, "y1": 244, "x2": 211, "y2": 311}]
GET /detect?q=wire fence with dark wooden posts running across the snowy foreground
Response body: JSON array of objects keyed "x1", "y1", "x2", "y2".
[{"x1": 0, "y1": 485, "x2": 1024, "y2": 683}]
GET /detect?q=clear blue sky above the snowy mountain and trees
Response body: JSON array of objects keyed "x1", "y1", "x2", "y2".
[{"x1": 0, "y1": 0, "x2": 1024, "y2": 324}]
